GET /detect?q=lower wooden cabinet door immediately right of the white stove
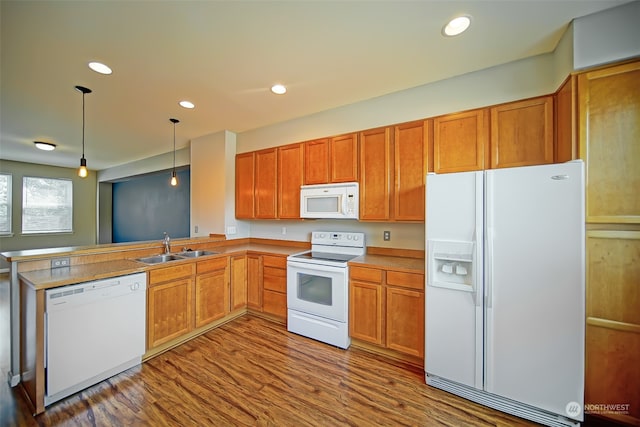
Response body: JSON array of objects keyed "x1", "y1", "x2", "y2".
[{"x1": 349, "y1": 280, "x2": 384, "y2": 345}]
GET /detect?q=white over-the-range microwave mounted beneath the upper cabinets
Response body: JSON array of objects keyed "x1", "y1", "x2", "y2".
[{"x1": 300, "y1": 182, "x2": 360, "y2": 219}]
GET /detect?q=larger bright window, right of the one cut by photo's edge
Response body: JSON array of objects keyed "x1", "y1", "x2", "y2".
[{"x1": 22, "y1": 176, "x2": 73, "y2": 234}]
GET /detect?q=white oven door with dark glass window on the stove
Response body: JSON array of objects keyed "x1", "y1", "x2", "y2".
[{"x1": 287, "y1": 261, "x2": 349, "y2": 322}]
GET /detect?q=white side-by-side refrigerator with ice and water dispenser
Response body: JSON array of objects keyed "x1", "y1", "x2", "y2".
[{"x1": 425, "y1": 161, "x2": 585, "y2": 426}]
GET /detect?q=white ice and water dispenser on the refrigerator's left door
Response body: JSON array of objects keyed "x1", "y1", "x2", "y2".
[{"x1": 427, "y1": 240, "x2": 474, "y2": 292}]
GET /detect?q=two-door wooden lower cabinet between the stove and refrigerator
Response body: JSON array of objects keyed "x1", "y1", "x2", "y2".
[{"x1": 349, "y1": 266, "x2": 424, "y2": 360}]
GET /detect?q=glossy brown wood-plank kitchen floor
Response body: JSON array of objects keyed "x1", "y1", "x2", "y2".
[{"x1": 0, "y1": 277, "x2": 608, "y2": 426}]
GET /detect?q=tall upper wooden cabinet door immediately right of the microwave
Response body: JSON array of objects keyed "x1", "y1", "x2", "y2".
[{"x1": 360, "y1": 128, "x2": 392, "y2": 221}]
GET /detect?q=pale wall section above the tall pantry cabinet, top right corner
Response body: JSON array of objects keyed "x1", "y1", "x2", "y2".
[{"x1": 573, "y1": 1, "x2": 640, "y2": 70}]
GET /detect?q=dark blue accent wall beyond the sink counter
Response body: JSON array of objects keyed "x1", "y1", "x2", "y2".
[{"x1": 113, "y1": 169, "x2": 191, "y2": 243}]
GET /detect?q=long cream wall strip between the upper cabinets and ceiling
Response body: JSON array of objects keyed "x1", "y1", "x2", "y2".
[{"x1": 238, "y1": 53, "x2": 569, "y2": 153}]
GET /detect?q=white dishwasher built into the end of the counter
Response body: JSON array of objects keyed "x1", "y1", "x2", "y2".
[{"x1": 44, "y1": 273, "x2": 147, "y2": 406}]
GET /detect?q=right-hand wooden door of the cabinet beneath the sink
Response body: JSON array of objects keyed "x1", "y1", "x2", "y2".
[{"x1": 195, "y1": 268, "x2": 229, "y2": 328}]
